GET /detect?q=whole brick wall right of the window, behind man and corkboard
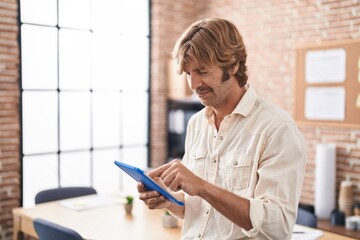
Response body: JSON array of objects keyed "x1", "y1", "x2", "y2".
[{"x1": 152, "y1": 0, "x2": 360, "y2": 208}]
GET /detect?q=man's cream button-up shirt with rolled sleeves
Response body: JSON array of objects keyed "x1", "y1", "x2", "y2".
[{"x1": 182, "y1": 87, "x2": 306, "y2": 240}]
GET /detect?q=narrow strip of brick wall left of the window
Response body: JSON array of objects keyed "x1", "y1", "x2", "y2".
[{"x1": 0, "y1": 0, "x2": 20, "y2": 239}]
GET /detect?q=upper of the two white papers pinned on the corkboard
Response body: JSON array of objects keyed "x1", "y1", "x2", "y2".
[{"x1": 305, "y1": 48, "x2": 346, "y2": 83}]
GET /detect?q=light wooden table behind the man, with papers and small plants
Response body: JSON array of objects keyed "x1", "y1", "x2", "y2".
[{"x1": 13, "y1": 197, "x2": 354, "y2": 240}]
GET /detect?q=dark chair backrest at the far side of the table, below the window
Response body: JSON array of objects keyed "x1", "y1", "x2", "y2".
[{"x1": 35, "y1": 187, "x2": 97, "y2": 204}]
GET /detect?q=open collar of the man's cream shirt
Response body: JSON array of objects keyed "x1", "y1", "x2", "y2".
[{"x1": 205, "y1": 84, "x2": 258, "y2": 120}]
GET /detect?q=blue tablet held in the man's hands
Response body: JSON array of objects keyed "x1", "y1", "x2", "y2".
[{"x1": 114, "y1": 161, "x2": 184, "y2": 206}]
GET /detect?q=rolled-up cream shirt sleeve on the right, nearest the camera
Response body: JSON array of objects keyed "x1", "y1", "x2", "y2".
[{"x1": 243, "y1": 122, "x2": 306, "y2": 239}]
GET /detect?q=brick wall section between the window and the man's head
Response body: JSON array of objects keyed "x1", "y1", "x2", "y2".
[{"x1": 151, "y1": 0, "x2": 198, "y2": 167}]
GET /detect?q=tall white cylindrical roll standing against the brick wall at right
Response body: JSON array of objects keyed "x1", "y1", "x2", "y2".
[{"x1": 315, "y1": 143, "x2": 336, "y2": 219}]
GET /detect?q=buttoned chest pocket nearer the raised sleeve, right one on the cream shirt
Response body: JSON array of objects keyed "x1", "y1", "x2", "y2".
[{"x1": 225, "y1": 154, "x2": 251, "y2": 191}]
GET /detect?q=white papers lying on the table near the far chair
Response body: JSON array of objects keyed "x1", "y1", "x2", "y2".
[{"x1": 59, "y1": 195, "x2": 125, "y2": 211}]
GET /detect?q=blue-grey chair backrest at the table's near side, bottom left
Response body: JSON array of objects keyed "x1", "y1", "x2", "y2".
[{"x1": 34, "y1": 218, "x2": 83, "y2": 240}]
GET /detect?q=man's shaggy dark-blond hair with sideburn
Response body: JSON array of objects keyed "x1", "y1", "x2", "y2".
[{"x1": 172, "y1": 18, "x2": 248, "y2": 87}]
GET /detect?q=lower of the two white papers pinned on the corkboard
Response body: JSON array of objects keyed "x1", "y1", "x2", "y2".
[{"x1": 304, "y1": 87, "x2": 345, "y2": 121}]
